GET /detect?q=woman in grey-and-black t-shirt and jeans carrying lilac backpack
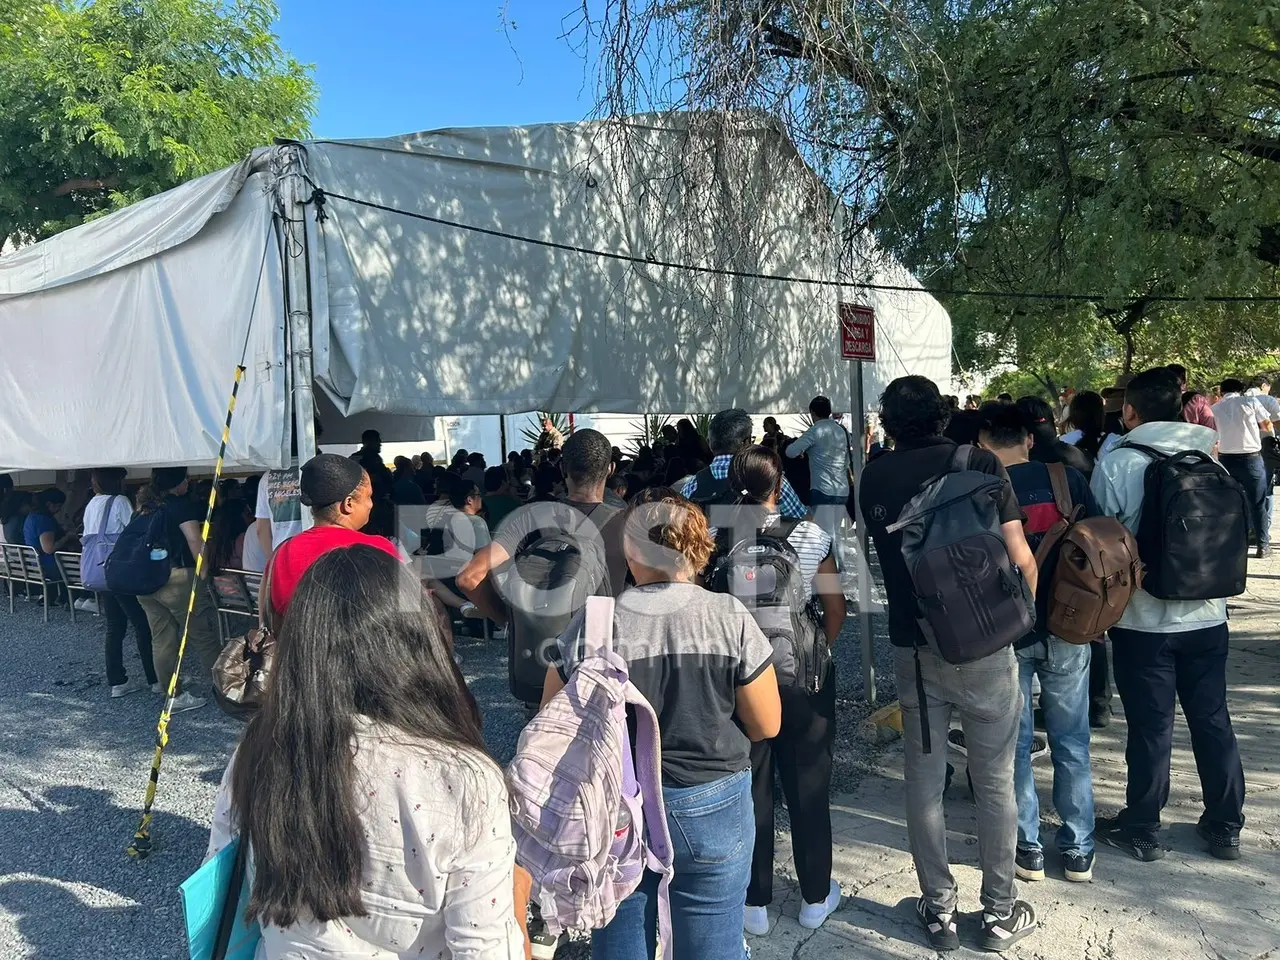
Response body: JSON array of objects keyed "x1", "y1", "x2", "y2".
[{"x1": 543, "y1": 486, "x2": 782, "y2": 960}]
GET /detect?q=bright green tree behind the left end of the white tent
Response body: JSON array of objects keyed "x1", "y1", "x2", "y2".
[{"x1": 0, "y1": 0, "x2": 316, "y2": 244}]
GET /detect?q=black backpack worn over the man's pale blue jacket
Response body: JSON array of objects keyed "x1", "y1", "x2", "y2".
[{"x1": 1123, "y1": 443, "x2": 1249, "y2": 600}]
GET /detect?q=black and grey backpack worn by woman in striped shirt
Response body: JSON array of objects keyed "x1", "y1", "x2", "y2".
[{"x1": 705, "y1": 520, "x2": 831, "y2": 695}]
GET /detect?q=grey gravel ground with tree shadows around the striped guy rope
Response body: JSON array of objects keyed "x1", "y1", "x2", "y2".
[{"x1": 0, "y1": 576, "x2": 893, "y2": 960}]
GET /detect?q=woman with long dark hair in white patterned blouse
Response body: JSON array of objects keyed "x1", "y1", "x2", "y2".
[{"x1": 209, "y1": 544, "x2": 525, "y2": 960}]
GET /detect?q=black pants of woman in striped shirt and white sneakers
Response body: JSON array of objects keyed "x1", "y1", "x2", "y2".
[{"x1": 746, "y1": 664, "x2": 836, "y2": 906}]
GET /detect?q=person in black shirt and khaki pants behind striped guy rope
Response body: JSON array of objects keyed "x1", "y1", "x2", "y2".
[{"x1": 138, "y1": 467, "x2": 223, "y2": 713}]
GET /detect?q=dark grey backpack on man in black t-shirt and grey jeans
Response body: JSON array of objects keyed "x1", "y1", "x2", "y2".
[{"x1": 888, "y1": 444, "x2": 1036, "y2": 751}]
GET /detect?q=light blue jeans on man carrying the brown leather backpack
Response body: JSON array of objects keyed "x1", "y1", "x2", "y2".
[{"x1": 1014, "y1": 636, "x2": 1093, "y2": 856}]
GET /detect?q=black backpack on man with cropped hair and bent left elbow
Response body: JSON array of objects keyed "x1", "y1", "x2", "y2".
[{"x1": 502, "y1": 504, "x2": 617, "y2": 704}]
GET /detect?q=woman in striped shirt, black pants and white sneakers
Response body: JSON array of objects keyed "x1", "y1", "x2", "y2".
[{"x1": 718, "y1": 447, "x2": 845, "y2": 936}]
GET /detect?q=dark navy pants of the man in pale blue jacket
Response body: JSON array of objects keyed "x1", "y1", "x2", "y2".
[{"x1": 1111, "y1": 623, "x2": 1244, "y2": 833}]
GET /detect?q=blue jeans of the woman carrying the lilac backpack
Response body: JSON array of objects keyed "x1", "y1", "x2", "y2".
[{"x1": 591, "y1": 771, "x2": 755, "y2": 960}]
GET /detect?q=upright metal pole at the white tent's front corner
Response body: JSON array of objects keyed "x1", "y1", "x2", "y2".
[{"x1": 284, "y1": 145, "x2": 316, "y2": 465}]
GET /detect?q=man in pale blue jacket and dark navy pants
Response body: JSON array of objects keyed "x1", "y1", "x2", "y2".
[{"x1": 1092, "y1": 369, "x2": 1244, "y2": 860}]
